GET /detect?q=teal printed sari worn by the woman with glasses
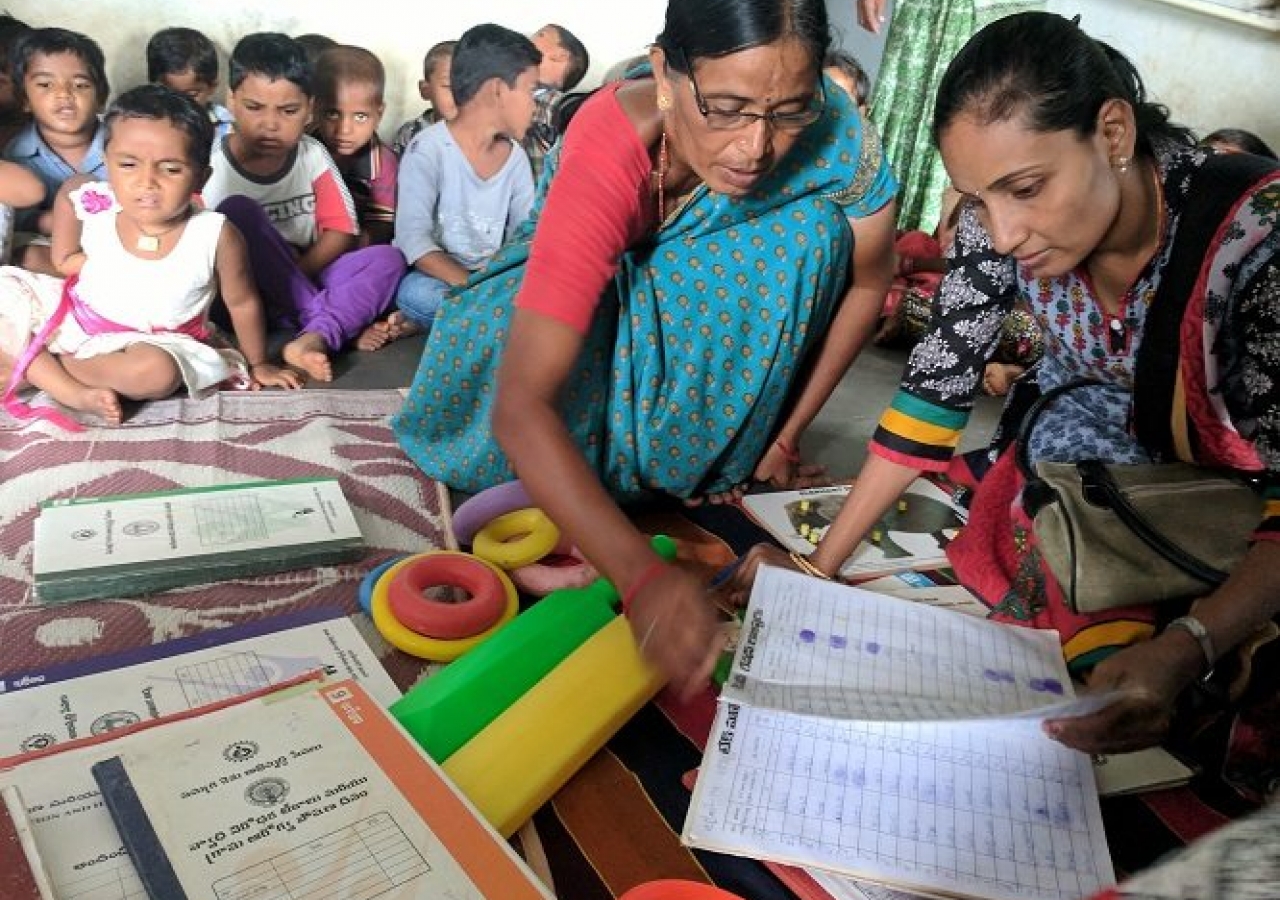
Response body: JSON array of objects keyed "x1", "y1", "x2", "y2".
[{"x1": 392, "y1": 84, "x2": 896, "y2": 501}]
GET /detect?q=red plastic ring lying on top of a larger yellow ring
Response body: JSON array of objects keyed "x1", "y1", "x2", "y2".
[{"x1": 387, "y1": 550, "x2": 507, "y2": 640}]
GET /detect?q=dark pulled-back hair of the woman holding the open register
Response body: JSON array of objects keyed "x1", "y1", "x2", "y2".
[{"x1": 933, "y1": 13, "x2": 1196, "y2": 156}]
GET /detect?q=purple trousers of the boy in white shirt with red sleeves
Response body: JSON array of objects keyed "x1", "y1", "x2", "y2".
[{"x1": 218, "y1": 196, "x2": 406, "y2": 350}]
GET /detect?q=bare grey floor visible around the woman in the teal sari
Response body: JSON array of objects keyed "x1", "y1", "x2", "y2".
[{"x1": 312, "y1": 335, "x2": 1000, "y2": 479}]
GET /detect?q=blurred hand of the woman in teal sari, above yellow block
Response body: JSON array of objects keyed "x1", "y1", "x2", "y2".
[{"x1": 627, "y1": 566, "x2": 723, "y2": 698}]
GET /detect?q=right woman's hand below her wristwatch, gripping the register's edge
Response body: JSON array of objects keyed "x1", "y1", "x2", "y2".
[{"x1": 1044, "y1": 631, "x2": 1204, "y2": 753}]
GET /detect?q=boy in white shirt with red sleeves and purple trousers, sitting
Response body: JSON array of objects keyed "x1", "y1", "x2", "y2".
[{"x1": 204, "y1": 32, "x2": 404, "y2": 382}]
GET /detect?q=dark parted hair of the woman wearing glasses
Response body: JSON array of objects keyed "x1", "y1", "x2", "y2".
[{"x1": 654, "y1": 0, "x2": 831, "y2": 74}]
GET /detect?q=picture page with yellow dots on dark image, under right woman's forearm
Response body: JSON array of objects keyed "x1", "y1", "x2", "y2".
[{"x1": 742, "y1": 478, "x2": 968, "y2": 580}]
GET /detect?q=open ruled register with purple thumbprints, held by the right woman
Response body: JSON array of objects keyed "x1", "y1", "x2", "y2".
[{"x1": 684, "y1": 567, "x2": 1114, "y2": 900}]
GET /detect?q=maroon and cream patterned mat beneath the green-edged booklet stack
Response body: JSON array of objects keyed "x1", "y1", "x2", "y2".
[{"x1": 0, "y1": 390, "x2": 445, "y2": 687}]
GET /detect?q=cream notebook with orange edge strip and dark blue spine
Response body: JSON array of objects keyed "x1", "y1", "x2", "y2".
[{"x1": 93, "y1": 681, "x2": 550, "y2": 900}]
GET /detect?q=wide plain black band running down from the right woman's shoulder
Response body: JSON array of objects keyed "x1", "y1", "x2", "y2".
[{"x1": 1133, "y1": 154, "x2": 1277, "y2": 462}]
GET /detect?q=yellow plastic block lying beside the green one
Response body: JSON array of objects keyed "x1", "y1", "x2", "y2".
[{"x1": 443, "y1": 617, "x2": 662, "y2": 837}]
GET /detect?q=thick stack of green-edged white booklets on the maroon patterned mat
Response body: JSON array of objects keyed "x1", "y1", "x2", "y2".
[{"x1": 33, "y1": 478, "x2": 365, "y2": 603}]
